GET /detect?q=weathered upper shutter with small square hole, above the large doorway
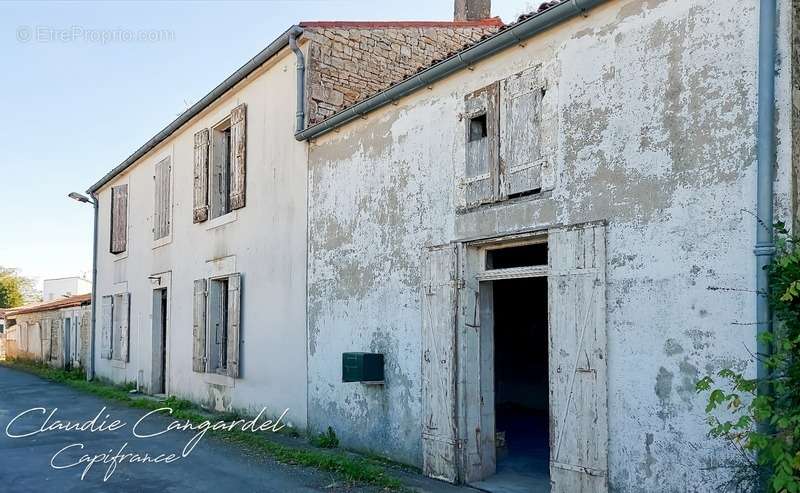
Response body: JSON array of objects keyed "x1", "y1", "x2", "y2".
[{"x1": 459, "y1": 83, "x2": 499, "y2": 207}]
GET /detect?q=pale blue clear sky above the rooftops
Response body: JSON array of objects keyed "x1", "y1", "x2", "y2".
[{"x1": 0, "y1": 0, "x2": 538, "y2": 288}]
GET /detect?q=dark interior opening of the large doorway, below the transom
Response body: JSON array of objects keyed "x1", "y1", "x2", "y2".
[{"x1": 493, "y1": 277, "x2": 550, "y2": 491}]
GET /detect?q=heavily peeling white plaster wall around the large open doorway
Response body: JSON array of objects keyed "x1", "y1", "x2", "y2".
[{"x1": 308, "y1": 0, "x2": 791, "y2": 491}]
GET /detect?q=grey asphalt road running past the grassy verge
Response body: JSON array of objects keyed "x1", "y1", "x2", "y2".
[{"x1": 0, "y1": 367, "x2": 369, "y2": 493}]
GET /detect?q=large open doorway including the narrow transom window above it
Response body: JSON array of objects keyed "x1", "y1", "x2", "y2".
[{"x1": 473, "y1": 243, "x2": 550, "y2": 493}]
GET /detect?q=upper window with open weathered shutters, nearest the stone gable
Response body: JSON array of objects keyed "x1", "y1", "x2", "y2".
[{"x1": 193, "y1": 104, "x2": 247, "y2": 223}]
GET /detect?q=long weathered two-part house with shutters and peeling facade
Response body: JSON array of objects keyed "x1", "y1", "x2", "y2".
[{"x1": 84, "y1": 0, "x2": 800, "y2": 492}]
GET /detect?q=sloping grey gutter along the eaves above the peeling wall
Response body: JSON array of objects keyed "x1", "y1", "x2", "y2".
[{"x1": 294, "y1": 0, "x2": 606, "y2": 141}]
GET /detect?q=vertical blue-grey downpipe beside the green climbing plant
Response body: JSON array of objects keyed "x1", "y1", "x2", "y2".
[{"x1": 753, "y1": 0, "x2": 777, "y2": 416}]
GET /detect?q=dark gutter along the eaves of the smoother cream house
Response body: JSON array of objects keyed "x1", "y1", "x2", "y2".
[{"x1": 87, "y1": 26, "x2": 297, "y2": 195}]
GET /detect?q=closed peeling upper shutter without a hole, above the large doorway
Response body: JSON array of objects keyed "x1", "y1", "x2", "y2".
[{"x1": 500, "y1": 67, "x2": 545, "y2": 198}]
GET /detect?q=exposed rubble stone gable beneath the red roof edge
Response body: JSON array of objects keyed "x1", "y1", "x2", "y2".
[{"x1": 301, "y1": 19, "x2": 502, "y2": 124}]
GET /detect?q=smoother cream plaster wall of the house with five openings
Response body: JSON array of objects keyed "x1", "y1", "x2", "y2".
[{"x1": 95, "y1": 49, "x2": 307, "y2": 428}]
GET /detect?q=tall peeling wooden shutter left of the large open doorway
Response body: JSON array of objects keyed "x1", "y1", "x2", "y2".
[{"x1": 422, "y1": 245, "x2": 458, "y2": 483}]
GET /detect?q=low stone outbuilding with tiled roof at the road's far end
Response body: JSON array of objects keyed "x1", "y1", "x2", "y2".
[{"x1": 5, "y1": 294, "x2": 91, "y2": 369}]
